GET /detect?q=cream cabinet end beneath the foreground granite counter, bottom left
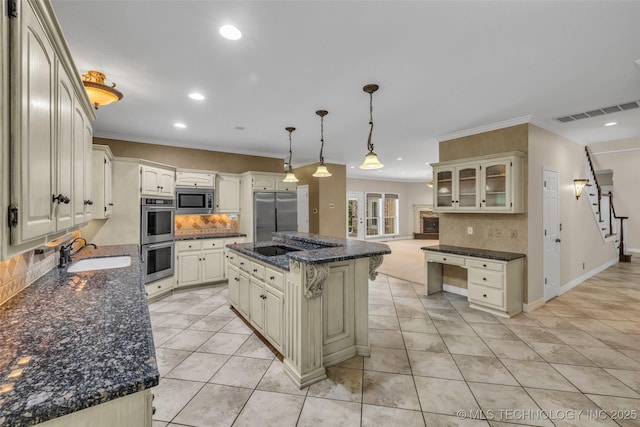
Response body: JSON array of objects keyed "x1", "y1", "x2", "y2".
[{"x1": 37, "y1": 389, "x2": 153, "y2": 427}]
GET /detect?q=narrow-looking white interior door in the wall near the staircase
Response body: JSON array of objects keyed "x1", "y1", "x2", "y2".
[{"x1": 542, "y1": 169, "x2": 560, "y2": 301}]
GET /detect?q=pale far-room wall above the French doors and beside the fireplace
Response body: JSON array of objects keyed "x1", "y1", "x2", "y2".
[{"x1": 347, "y1": 178, "x2": 433, "y2": 238}]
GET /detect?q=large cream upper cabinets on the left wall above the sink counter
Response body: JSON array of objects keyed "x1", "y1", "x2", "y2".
[{"x1": 8, "y1": 0, "x2": 95, "y2": 245}]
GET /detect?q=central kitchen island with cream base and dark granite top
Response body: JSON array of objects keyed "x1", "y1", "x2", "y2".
[{"x1": 227, "y1": 232, "x2": 391, "y2": 388}]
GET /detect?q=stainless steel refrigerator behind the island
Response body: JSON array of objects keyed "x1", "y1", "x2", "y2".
[{"x1": 253, "y1": 192, "x2": 298, "y2": 242}]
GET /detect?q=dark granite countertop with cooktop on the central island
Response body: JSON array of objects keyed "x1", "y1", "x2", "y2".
[{"x1": 227, "y1": 232, "x2": 391, "y2": 270}]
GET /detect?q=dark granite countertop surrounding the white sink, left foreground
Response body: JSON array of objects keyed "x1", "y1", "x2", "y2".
[{"x1": 0, "y1": 245, "x2": 159, "y2": 426}]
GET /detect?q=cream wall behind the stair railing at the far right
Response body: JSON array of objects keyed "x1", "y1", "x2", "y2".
[{"x1": 589, "y1": 138, "x2": 640, "y2": 252}]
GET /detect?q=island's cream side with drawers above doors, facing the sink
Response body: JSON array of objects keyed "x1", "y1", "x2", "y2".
[{"x1": 228, "y1": 251, "x2": 285, "y2": 352}]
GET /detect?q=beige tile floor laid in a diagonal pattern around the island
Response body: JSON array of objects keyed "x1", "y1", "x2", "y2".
[{"x1": 149, "y1": 259, "x2": 640, "y2": 427}]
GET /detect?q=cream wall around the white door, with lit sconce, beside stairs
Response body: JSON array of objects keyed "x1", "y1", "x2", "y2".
[{"x1": 527, "y1": 125, "x2": 617, "y2": 304}]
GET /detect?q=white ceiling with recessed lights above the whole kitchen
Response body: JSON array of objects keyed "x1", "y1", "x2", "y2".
[{"x1": 53, "y1": 0, "x2": 640, "y2": 181}]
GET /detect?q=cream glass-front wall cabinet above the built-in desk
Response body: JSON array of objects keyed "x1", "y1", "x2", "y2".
[{"x1": 431, "y1": 152, "x2": 524, "y2": 213}]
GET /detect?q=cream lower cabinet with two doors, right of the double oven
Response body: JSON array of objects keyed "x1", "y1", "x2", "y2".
[{"x1": 176, "y1": 239, "x2": 224, "y2": 287}]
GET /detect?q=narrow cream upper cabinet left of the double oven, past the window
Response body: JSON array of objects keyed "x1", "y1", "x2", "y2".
[{"x1": 92, "y1": 144, "x2": 113, "y2": 219}]
